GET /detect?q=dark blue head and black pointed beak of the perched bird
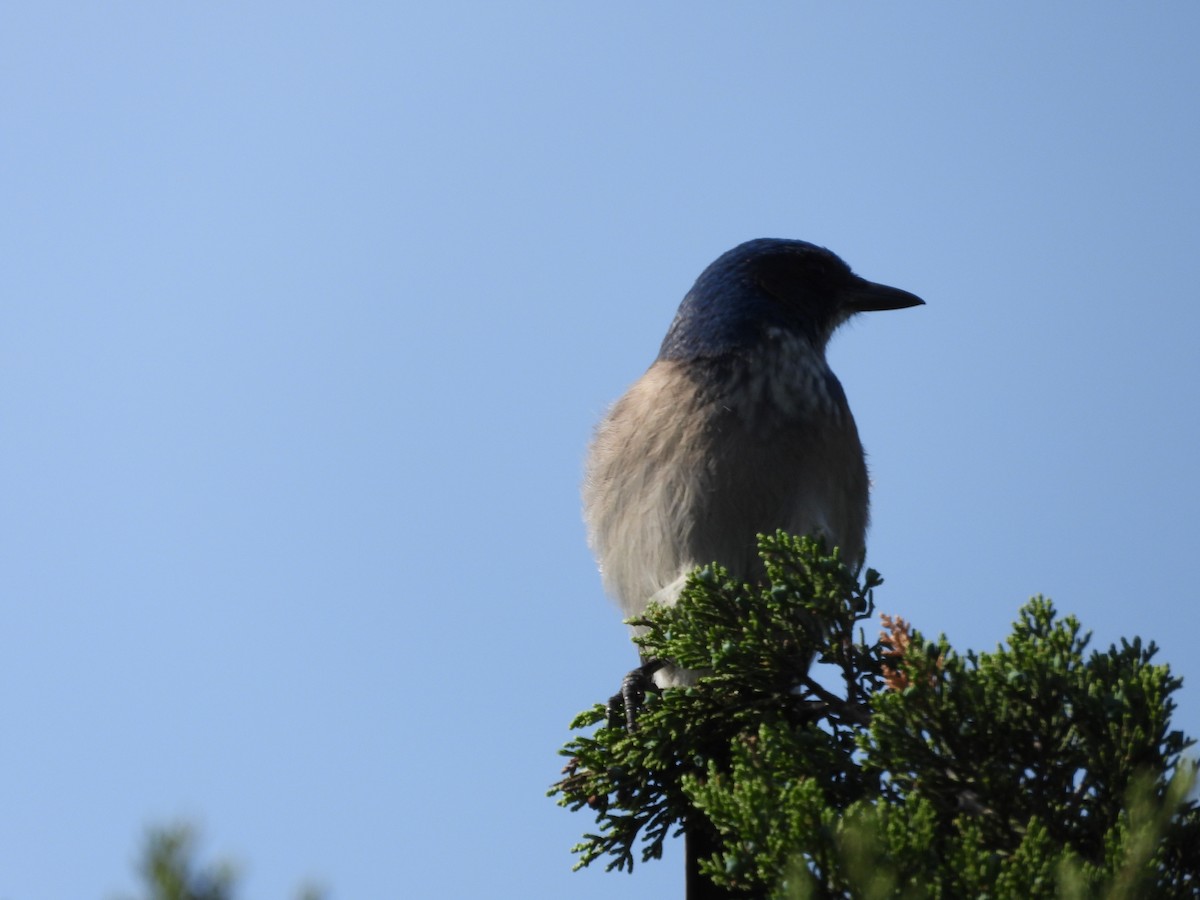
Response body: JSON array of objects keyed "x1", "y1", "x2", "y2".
[{"x1": 659, "y1": 238, "x2": 924, "y2": 361}]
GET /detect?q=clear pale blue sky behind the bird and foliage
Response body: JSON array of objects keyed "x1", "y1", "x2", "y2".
[{"x1": 0, "y1": 0, "x2": 1200, "y2": 900}]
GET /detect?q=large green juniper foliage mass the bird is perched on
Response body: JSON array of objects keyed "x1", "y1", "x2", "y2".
[{"x1": 551, "y1": 533, "x2": 1200, "y2": 900}]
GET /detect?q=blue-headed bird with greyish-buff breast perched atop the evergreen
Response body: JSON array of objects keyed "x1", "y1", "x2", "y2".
[{"x1": 582, "y1": 238, "x2": 924, "y2": 686}]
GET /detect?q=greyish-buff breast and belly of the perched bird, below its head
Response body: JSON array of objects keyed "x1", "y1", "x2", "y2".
[{"x1": 583, "y1": 342, "x2": 868, "y2": 614}]
